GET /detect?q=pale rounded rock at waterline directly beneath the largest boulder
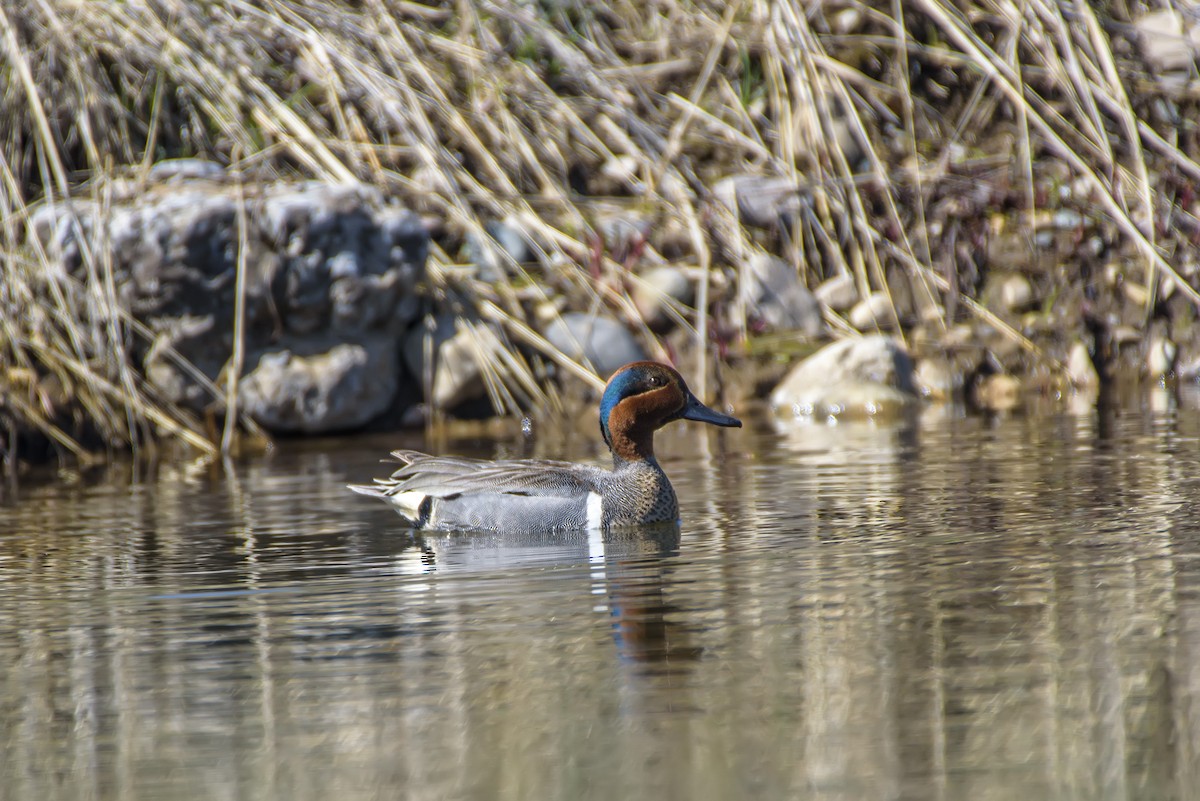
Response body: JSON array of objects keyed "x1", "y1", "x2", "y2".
[{"x1": 239, "y1": 337, "x2": 398, "y2": 434}]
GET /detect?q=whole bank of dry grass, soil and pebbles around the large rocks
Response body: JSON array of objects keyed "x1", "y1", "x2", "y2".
[{"x1": 0, "y1": 0, "x2": 1200, "y2": 465}]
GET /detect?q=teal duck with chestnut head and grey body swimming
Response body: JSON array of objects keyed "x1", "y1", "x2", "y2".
[{"x1": 349, "y1": 361, "x2": 742, "y2": 532}]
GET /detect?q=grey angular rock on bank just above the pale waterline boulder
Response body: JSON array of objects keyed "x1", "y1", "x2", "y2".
[{"x1": 738, "y1": 253, "x2": 826, "y2": 337}]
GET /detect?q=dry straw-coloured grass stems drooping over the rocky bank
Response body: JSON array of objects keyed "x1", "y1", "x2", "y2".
[{"x1": 0, "y1": 0, "x2": 1200, "y2": 456}]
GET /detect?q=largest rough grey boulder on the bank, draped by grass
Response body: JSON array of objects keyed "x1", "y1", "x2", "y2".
[{"x1": 25, "y1": 176, "x2": 428, "y2": 430}]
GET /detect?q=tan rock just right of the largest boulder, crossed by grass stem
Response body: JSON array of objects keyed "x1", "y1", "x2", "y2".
[{"x1": 404, "y1": 314, "x2": 487, "y2": 412}]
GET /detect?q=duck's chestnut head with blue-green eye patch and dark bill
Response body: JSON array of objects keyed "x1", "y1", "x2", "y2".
[{"x1": 600, "y1": 362, "x2": 742, "y2": 462}]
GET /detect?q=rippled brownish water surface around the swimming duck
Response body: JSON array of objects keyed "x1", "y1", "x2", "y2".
[{"x1": 7, "y1": 403, "x2": 1200, "y2": 801}]
